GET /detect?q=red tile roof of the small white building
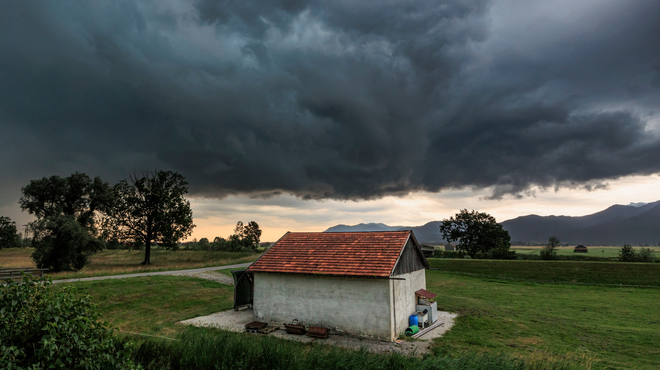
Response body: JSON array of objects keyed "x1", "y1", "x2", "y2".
[{"x1": 247, "y1": 231, "x2": 411, "y2": 277}]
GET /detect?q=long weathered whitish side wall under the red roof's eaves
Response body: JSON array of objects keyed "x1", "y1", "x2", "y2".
[{"x1": 253, "y1": 271, "x2": 392, "y2": 340}]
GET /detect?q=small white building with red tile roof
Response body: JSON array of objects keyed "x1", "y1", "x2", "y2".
[{"x1": 246, "y1": 231, "x2": 429, "y2": 341}]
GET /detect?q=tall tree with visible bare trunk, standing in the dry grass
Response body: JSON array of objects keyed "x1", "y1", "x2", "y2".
[{"x1": 106, "y1": 171, "x2": 195, "y2": 265}]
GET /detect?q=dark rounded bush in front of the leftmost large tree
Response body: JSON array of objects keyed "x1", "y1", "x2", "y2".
[{"x1": 32, "y1": 216, "x2": 103, "y2": 272}]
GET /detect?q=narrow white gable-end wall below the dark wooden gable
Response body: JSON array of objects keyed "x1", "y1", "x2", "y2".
[{"x1": 390, "y1": 270, "x2": 426, "y2": 340}]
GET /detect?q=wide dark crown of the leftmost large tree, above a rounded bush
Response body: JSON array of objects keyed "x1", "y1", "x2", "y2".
[{"x1": 19, "y1": 172, "x2": 113, "y2": 233}]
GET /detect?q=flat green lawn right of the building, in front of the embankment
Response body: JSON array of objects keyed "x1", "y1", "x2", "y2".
[{"x1": 427, "y1": 271, "x2": 660, "y2": 368}]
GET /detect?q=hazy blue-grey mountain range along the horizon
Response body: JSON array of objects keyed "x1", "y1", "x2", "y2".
[{"x1": 325, "y1": 201, "x2": 660, "y2": 245}]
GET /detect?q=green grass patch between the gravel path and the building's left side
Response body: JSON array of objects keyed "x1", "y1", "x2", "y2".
[{"x1": 70, "y1": 276, "x2": 234, "y2": 337}]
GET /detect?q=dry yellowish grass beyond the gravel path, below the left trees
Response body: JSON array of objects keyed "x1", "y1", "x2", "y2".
[{"x1": 0, "y1": 248, "x2": 259, "y2": 279}]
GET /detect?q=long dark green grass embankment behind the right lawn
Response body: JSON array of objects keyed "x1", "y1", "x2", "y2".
[{"x1": 429, "y1": 258, "x2": 660, "y2": 286}]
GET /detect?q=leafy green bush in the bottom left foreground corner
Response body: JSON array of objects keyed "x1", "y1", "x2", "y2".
[{"x1": 0, "y1": 275, "x2": 141, "y2": 370}]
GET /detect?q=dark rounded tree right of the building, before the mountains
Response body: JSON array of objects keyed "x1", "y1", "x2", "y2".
[{"x1": 440, "y1": 209, "x2": 511, "y2": 258}]
